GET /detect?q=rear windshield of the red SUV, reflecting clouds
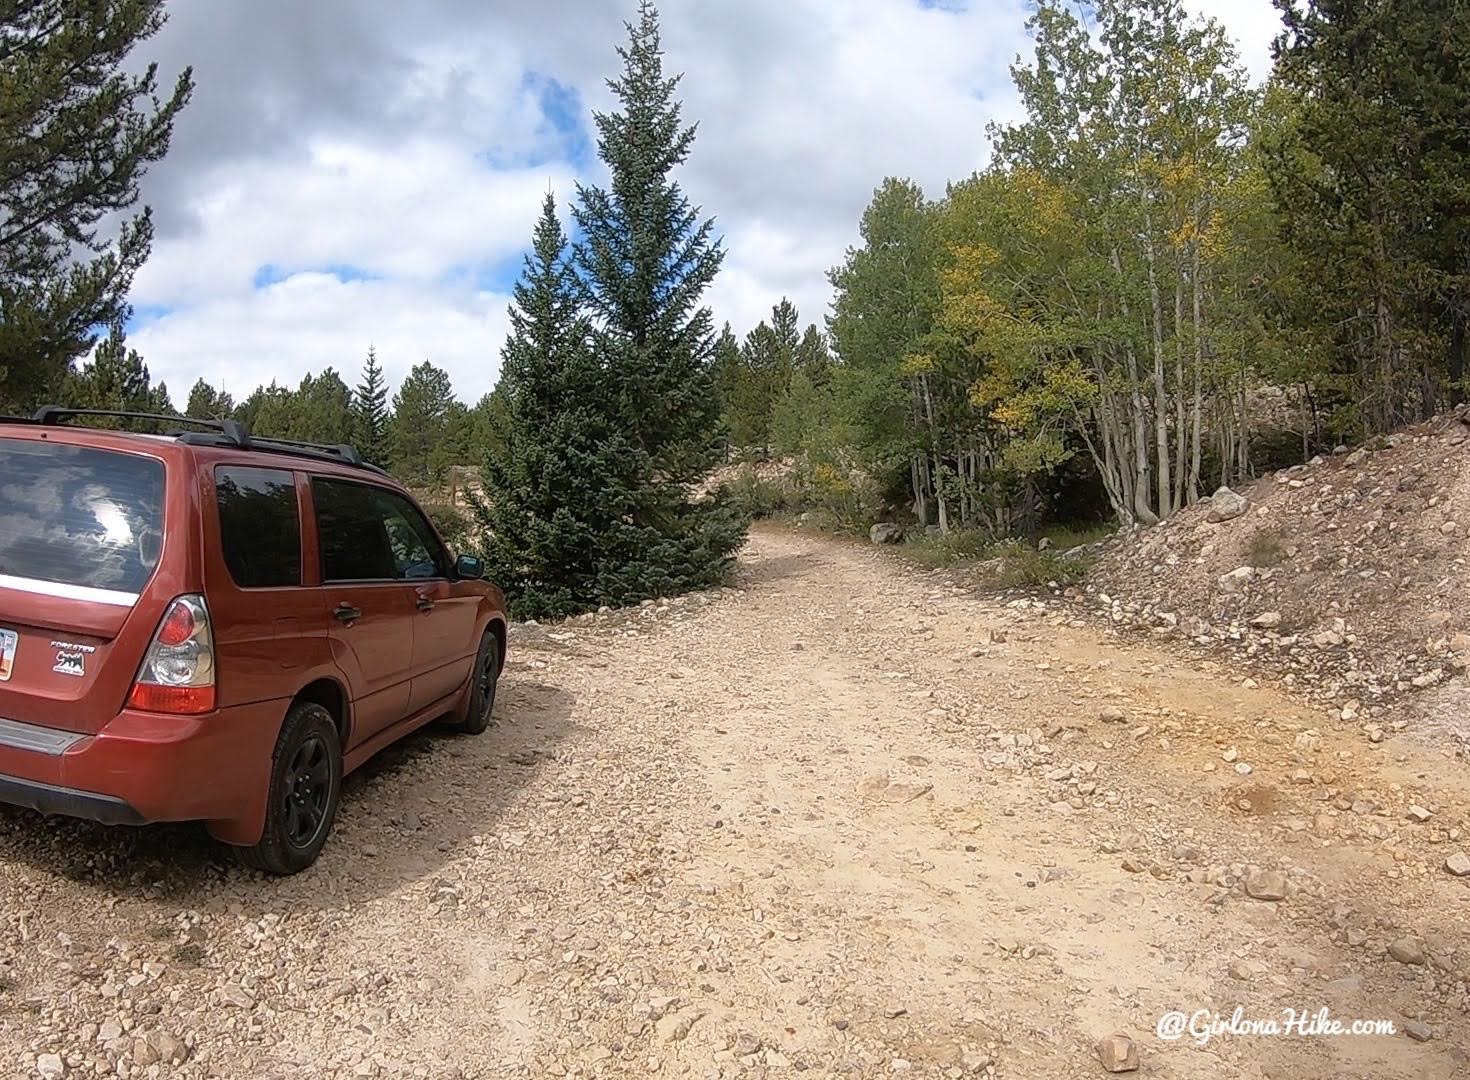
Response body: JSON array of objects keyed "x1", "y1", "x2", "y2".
[{"x1": 0, "y1": 439, "x2": 163, "y2": 594}]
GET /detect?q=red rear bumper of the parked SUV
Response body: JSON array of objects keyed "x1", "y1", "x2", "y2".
[{"x1": 0, "y1": 701, "x2": 287, "y2": 833}]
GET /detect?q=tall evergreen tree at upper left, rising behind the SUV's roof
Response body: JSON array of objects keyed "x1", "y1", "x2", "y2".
[{"x1": 0, "y1": 0, "x2": 193, "y2": 411}]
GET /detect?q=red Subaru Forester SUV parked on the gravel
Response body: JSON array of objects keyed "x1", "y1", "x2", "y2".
[{"x1": 0, "y1": 407, "x2": 506, "y2": 874}]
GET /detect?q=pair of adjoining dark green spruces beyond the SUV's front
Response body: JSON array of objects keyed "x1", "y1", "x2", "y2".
[{"x1": 482, "y1": 1, "x2": 744, "y2": 616}]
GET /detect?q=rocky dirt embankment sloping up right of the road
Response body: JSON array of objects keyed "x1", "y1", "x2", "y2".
[{"x1": 1073, "y1": 408, "x2": 1470, "y2": 736}]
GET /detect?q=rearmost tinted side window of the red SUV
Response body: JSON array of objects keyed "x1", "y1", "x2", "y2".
[{"x1": 215, "y1": 466, "x2": 301, "y2": 589}]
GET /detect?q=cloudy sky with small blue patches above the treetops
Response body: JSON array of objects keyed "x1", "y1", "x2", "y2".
[{"x1": 131, "y1": 0, "x2": 1277, "y2": 406}]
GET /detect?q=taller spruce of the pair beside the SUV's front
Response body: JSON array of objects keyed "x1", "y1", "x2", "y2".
[{"x1": 573, "y1": 0, "x2": 742, "y2": 602}]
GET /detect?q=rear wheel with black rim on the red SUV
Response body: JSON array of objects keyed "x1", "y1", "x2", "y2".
[{"x1": 235, "y1": 701, "x2": 343, "y2": 874}]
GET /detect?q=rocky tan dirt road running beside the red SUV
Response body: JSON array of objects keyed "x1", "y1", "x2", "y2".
[{"x1": 0, "y1": 530, "x2": 1470, "y2": 1080}]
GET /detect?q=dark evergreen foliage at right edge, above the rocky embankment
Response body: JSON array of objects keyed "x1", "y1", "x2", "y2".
[{"x1": 1263, "y1": 0, "x2": 1470, "y2": 436}]
